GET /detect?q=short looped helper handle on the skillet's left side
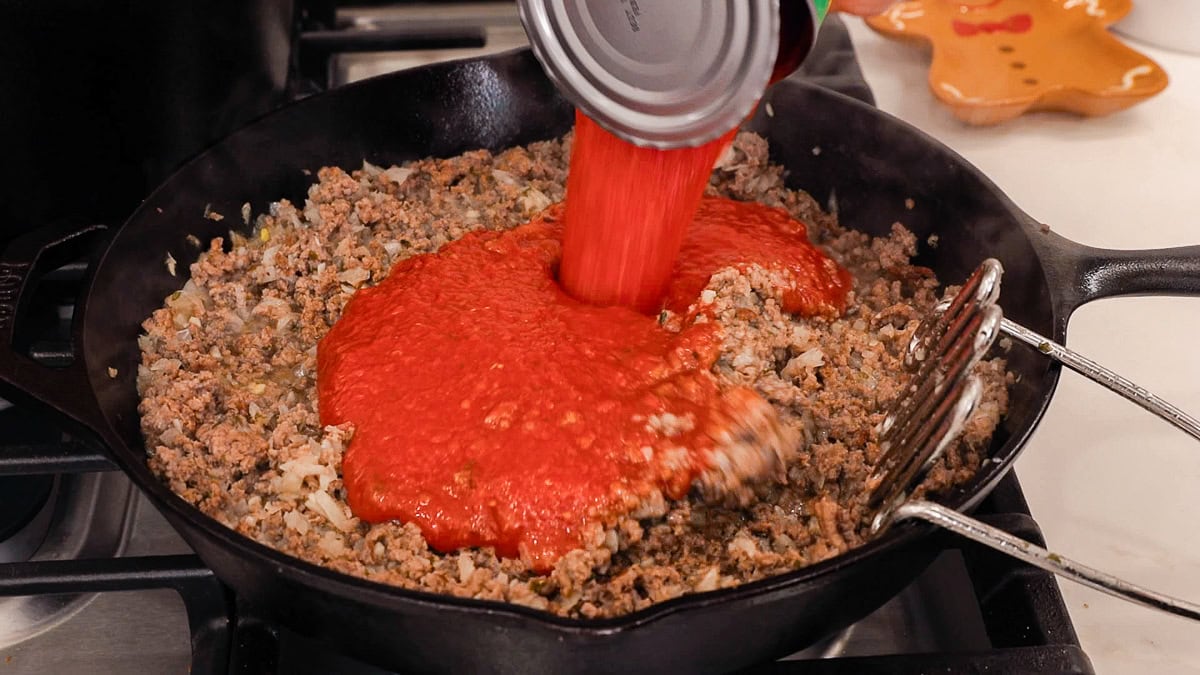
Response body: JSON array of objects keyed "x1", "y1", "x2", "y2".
[{"x1": 0, "y1": 222, "x2": 114, "y2": 449}]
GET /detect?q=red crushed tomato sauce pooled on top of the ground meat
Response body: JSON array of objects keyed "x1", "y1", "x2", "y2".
[{"x1": 318, "y1": 198, "x2": 850, "y2": 572}]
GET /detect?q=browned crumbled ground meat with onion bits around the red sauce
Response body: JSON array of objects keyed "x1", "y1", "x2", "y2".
[{"x1": 138, "y1": 133, "x2": 1009, "y2": 617}]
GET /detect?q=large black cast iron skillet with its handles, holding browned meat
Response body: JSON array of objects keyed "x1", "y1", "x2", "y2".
[{"x1": 0, "y1": 52, "x2": 1200, "y2": 673}]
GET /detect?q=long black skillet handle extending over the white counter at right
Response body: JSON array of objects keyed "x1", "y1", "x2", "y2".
[{"x1": 1036, "y1": 225, "x2": 1200, "y2": 309}]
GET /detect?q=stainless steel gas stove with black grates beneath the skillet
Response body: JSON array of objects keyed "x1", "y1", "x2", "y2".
[{"x1": 0, "y1": 2, "x2": 1092, "y2": 675}]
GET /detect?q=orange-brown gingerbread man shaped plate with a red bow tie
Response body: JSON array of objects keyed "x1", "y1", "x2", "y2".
[{"x1": 866, "y1": 0, "x2": 1166, "y2": 125}]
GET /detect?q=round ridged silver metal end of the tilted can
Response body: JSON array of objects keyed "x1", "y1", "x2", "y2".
[{"x1": 518, "y1": 0, "x2": 779, "y2": 148}]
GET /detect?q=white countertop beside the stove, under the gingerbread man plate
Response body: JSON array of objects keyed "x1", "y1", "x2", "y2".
[{"x1": 847, "y1": 17, "x2": 1200, "y2": 674}]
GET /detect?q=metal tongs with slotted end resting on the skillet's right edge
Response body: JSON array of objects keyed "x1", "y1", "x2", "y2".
[{"x1": 868, "y1": 258, "x2": 1200, "y2": 621}]
